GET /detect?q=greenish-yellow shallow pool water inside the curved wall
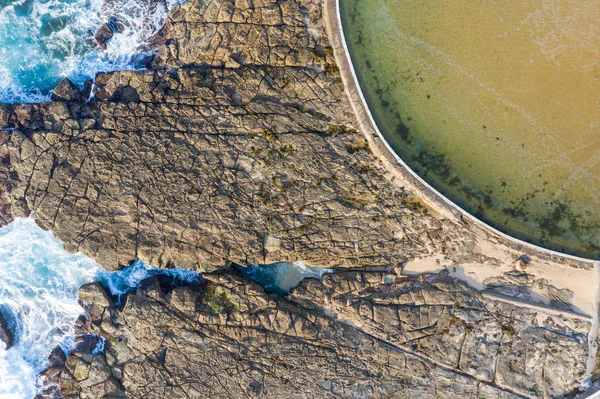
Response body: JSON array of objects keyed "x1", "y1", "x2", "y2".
[{"x1": 340, "y1": 0, "x2": 600, "y2": 259}]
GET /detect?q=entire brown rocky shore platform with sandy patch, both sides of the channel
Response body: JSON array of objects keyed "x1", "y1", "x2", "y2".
[{"x1": 0, "y1": 0, "x2": 600, "y2": 399}]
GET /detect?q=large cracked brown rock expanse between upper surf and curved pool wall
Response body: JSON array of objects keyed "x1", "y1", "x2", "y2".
[{"x1": 0, "y1": 0, "x2": 585, "y2": 271}]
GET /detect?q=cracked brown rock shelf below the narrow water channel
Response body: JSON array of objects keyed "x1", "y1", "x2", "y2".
[{"x1": 45, "y1": 269, "x2": 589, "y2": 398}]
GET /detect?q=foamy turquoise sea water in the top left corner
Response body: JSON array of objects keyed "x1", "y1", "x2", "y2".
[{"x1": 0, "y1": 0, "x2": 177, "y2": 103}]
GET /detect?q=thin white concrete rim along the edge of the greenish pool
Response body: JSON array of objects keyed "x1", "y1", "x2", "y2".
[{"x1": 335, "y1": 0, "x2": 600, "y2": 266}]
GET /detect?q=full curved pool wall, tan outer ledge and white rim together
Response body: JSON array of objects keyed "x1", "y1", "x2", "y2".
[{"x1": 324, "y1": 0, "x2": 600, "y2": 266}]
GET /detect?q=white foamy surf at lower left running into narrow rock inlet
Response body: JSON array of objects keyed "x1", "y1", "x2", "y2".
[{"x1": 0, "y1": 219, "x2": 202, "y2": 399}]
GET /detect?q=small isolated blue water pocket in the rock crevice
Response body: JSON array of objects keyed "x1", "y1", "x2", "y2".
[{"x1": 239, "y1": 262, "x2": 333, "y2": 295}]
